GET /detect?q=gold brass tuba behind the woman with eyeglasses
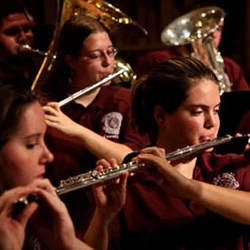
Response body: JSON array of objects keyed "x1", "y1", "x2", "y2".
[{"x1": 20, "y1": 0, "x2": 147, "y2": 90}]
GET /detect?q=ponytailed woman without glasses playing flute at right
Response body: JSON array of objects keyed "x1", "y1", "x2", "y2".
[{"x1": 99, "y1": 57, "x2": 250, "y2": 250}]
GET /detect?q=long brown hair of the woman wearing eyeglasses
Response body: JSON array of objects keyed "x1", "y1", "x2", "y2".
[{"x1": 42, "y1": 15, "x2": 110, "y2": 101}]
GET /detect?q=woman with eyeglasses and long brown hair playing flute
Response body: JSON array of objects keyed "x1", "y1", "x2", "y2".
[{"x1": 37, "y1": 15, "x2": 147, "y2": 239}]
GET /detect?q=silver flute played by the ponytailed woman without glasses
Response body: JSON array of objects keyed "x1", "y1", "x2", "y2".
[{"x1": 56, "y1": 135, "x2": 238, "y2": 195}]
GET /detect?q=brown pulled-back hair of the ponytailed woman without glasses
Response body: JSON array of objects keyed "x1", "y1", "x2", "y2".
[{"x1": 131, "y1": 57, "x2": 219, "y2": 143}]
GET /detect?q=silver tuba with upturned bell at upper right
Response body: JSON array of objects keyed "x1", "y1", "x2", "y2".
[{"x1": 161, "y1": 6, "x2": 232, "y2": 94}]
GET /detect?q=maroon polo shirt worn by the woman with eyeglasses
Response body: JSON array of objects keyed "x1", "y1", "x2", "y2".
[{"x1": 46, "y1": 87, "x2": 148, "y2": 236}]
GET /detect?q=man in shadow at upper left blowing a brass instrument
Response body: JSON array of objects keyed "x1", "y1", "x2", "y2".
[{"x1": 0, "y1": 0, "x2": 37, "y2": 82}]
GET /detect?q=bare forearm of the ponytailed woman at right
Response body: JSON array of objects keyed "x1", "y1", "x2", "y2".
[{"x1": 146, "y1": 156, "x2": 250, "y2": 225}]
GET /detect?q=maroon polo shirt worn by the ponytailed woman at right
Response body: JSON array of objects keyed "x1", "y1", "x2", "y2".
[{"x1": 109, "y1": 153, "x2": 250, "y2": 250}]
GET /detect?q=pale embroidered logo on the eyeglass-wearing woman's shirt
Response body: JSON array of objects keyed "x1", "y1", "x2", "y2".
[{"x1": 102, "y1": 112, "x2": 122, "y2": 138}]
